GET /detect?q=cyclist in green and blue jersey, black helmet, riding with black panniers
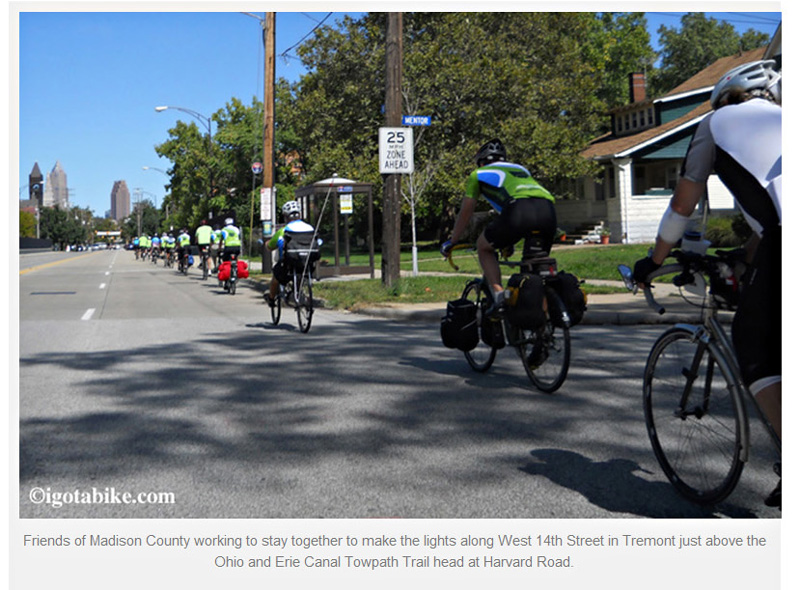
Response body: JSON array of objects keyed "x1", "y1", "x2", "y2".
[{"x1": 441, "y1": 139, "x2": 556, "y2": 309}]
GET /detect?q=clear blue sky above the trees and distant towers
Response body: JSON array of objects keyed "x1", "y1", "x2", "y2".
[{"x1": 10, "y1": 9, "x2": 780, "y2": 216}]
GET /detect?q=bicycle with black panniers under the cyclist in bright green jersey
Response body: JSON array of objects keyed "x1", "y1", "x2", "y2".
[{"x1": 447, "y1": 244, "x2": 572, "y2": 393}]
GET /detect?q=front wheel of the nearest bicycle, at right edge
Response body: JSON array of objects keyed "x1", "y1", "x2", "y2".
[{"x1": 644, "y1": 327, "x2": 748, "y2": 504}]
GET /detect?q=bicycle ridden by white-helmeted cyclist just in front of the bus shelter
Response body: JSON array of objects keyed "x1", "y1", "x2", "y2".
[{"x1": 270, "y1": 239, "x2": 319, "y2": 334}]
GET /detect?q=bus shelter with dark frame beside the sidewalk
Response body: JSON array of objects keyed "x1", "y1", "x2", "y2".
[{"x1": 294, "y1": 176, "x2": 375, "y2": 278}]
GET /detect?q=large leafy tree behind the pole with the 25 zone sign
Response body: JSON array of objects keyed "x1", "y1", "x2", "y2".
[{"x1": 288, "y1": 12, "x2": 632, "y2": 240}]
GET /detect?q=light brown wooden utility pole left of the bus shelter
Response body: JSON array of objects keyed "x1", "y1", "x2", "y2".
[{"x1": 261, "y1": 12, "x2": 276, "y2": 272}]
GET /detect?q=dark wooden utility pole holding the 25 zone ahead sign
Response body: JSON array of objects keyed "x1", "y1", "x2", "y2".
[{"x1": 381, "y1": 12, "x2": 403, "y2": 287}]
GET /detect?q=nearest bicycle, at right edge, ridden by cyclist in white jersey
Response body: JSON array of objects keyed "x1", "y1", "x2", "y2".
[{"x1": 619, "y1": 250, "x2": 781, "y2": 505}]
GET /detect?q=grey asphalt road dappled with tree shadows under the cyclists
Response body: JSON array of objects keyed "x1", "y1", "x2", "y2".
[{"x1": 19, "y1": 251, "x2": 780, "y2": 518}]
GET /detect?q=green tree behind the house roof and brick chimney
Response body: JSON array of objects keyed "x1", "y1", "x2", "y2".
[{"x1": 653, "y1": 12, "x2": 769, "y2": 94}]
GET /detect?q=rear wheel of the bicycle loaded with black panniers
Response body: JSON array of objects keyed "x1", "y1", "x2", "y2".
[{"x1": 513, "y1": 287, "x2": 572, "y2": 393}]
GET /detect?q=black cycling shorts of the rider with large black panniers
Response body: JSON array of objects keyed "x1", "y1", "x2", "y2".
[{"x1": 484, "y1": 197, "x2": 557, "y2": 253}]
